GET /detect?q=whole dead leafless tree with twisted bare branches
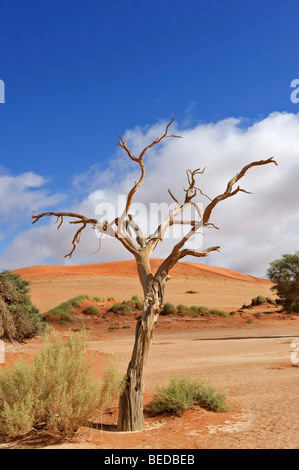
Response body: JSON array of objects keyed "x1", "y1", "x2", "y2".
[{"x1": 32, "y1": 117, "x2": 277, "y2": 431}]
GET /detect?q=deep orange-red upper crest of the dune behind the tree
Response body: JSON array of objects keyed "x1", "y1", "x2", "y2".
[{"x1": 14, "y1": 259, "x2": 271, "y2": 285}]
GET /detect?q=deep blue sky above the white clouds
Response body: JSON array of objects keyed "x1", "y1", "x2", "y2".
[{"x1": 0, "y1": 0, "x2": 299, "y2": 269}]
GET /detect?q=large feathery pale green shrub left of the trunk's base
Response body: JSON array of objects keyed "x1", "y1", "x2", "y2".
[{"x1": 0, "y1": 333, "x2": 122, "y2": 438}]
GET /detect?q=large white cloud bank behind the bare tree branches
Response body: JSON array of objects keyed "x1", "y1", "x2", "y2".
[{"x1": 0, "y1": 112, "x2": 299, "y2": 276}]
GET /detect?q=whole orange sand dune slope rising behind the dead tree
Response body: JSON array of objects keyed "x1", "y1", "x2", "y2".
[{"x1": 15, "y1": 259, "x2": 273, "y2": 313}]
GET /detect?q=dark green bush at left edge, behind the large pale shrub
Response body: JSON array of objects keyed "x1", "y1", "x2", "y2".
[{"x1": 0, "y1": 271, "x2": 45, "y2": 341}]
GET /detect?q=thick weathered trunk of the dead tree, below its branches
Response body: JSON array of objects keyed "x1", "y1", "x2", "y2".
[{"x1": 117, "y1": 255, "x2": 165, "y2": 431}]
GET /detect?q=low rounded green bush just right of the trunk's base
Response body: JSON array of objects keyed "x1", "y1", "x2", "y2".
[{"x1": 152, "y1": 376, "x2": 230, "y2": 414}]
